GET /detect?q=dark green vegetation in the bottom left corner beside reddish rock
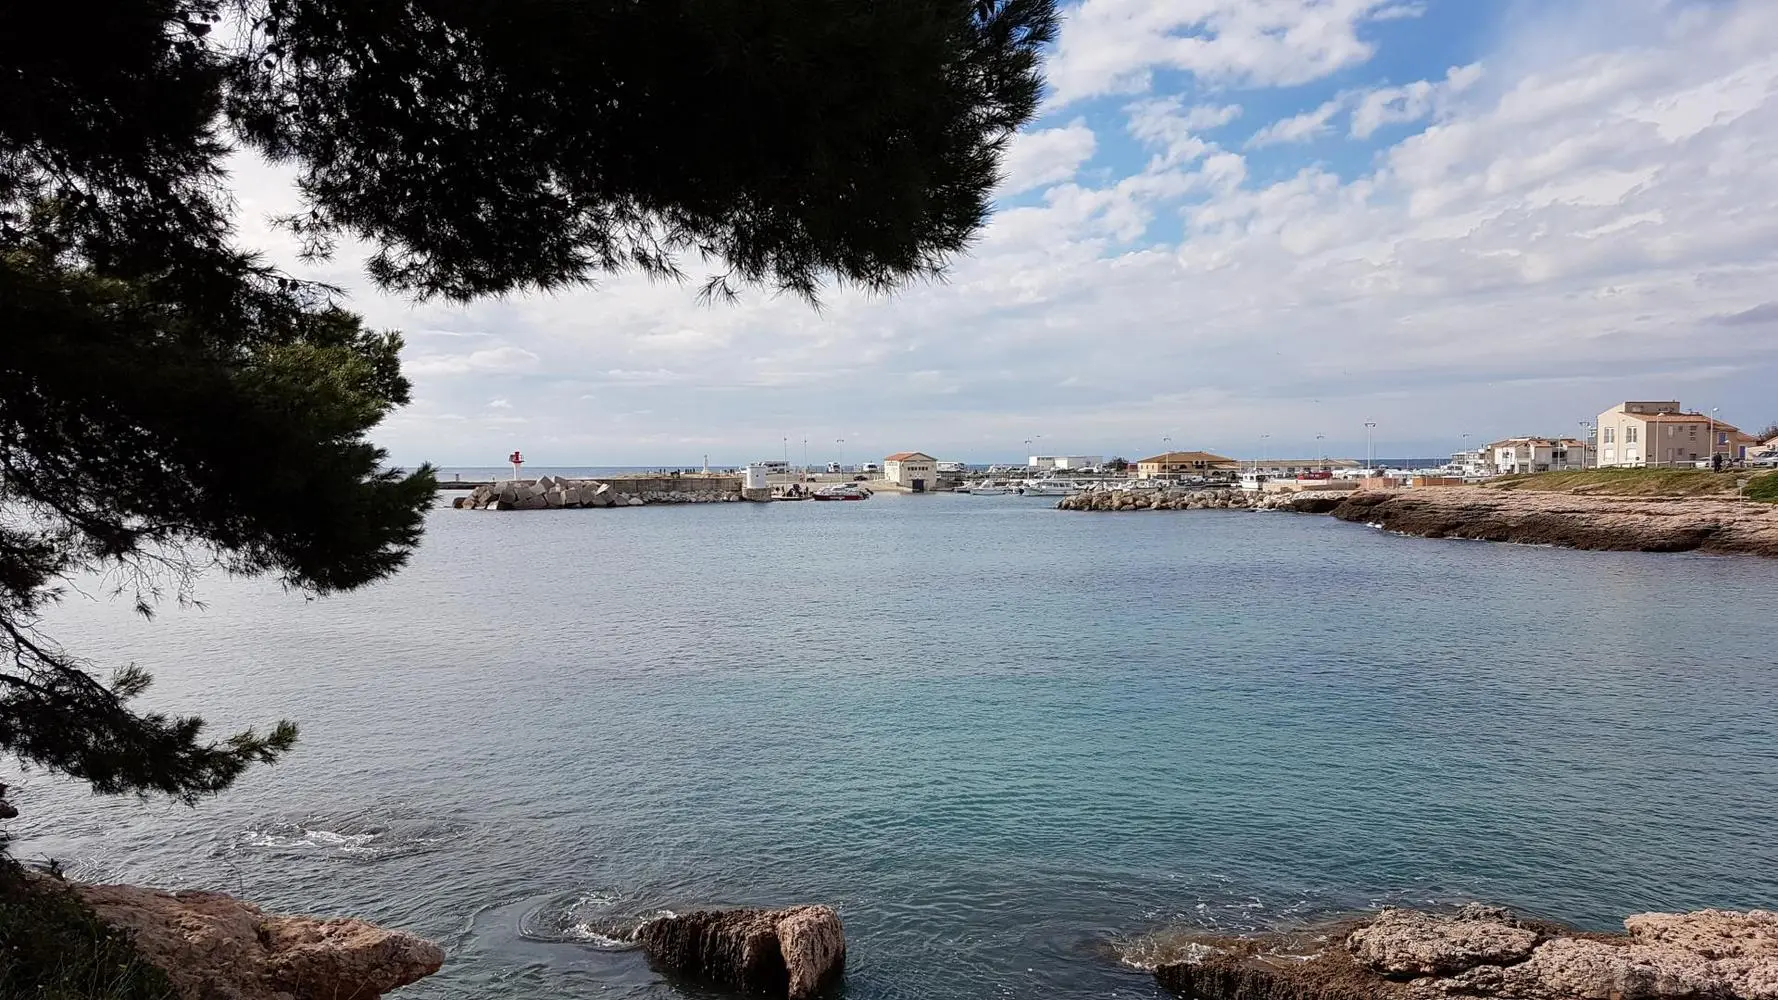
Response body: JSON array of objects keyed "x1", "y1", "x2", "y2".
[{"x1": 0, "y1": 858, "x2": 176, "y2": 1000}]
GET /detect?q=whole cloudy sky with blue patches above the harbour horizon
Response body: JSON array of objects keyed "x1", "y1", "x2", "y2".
[{"x1": 238, "y1": 0, "x2": 1778, "y2": 466}]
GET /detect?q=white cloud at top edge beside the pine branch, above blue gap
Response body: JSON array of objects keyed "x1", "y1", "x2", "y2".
[{"x1": 1047, "y1": 0, "x2": 1417, "y2": 105}]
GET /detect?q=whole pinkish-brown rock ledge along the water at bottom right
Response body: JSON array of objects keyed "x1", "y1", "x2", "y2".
[{"x1": 1143, "y1": 904, "x2": 1778, "y2": 1000}]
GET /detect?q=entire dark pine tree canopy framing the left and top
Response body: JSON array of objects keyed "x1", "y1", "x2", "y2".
[{"x1": 0, "y1": 0, "x2": 1056, "y2": 811}]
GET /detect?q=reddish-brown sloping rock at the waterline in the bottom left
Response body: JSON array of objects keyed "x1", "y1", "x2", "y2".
[{"x1": 58, "y1": 881, "x2": 445, "y2": 1000}]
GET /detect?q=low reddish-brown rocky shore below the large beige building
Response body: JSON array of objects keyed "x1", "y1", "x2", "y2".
[{"x1": 1322, "y1": 486, "x2": 1778, "y2": 557}]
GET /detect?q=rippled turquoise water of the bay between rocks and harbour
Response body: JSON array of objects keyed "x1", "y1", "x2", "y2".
[{"x1": 12, "y1": 495, "x2": 1778, "y2": 1000}]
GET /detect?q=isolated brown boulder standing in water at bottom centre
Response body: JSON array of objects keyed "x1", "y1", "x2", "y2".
[{"x1": 637, "y1": 906, "x2": 846, "y2": 1000}]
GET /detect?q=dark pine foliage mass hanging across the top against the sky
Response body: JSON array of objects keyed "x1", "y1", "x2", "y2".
[{"x1": 229, "y1": 0, "x2": 1056, "y2": 297}]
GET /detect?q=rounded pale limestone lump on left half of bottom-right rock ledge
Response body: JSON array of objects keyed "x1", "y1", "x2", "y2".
[{"x1": 1346, "y1": 909, "x2": 1538, "y2": 975}]
